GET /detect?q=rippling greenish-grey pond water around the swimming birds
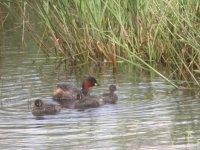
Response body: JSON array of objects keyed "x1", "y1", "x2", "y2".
[{"x1": 0, "y1": 31, "x2": 200, "y2": 150}]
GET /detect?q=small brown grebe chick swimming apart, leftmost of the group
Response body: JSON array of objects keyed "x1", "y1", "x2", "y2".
[{"x1": 32, "y1": 99, "x2": 61, "y2": 116}]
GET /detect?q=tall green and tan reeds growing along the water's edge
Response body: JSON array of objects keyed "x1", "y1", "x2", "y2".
[{"x1": 0, "y1": 0, "x2": 200, "y2": 87}]
